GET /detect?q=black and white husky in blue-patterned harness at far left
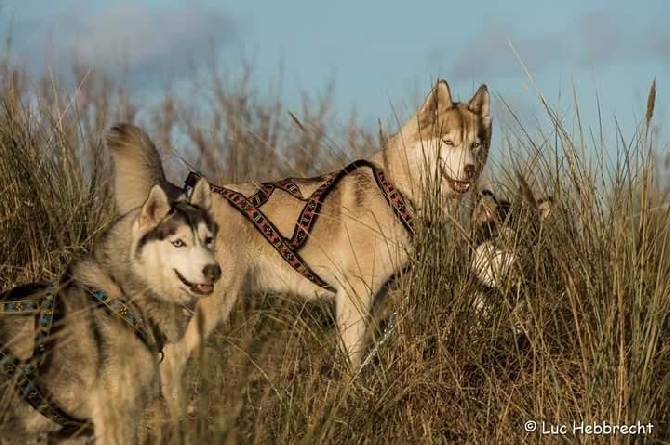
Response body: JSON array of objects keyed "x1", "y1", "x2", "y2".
[{"x1": 0, "y1": 179, "x2": 222, "y2": 444}]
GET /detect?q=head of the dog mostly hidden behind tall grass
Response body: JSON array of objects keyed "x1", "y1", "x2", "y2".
[{"x1": 471, "y1": 178, "x2": 552, "y2": 289}]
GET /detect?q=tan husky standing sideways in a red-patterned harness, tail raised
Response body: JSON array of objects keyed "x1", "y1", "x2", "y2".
[{"x1": 107, "y1": 80, "x2": 491, "y2": 406}]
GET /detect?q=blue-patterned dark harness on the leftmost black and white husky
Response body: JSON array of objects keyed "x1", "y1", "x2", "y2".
[{"x1": 0, "y1": 283, "x2": 162, "y2": 435}]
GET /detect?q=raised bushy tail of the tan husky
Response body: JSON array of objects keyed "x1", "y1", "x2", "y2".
[{"x1": 106, "y1": 123, "x2": 176, "y2": 214}]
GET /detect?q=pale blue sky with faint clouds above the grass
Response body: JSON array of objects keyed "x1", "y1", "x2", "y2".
[{"x1": 0, "y1": 0, "x2": 670, "y2": 168}]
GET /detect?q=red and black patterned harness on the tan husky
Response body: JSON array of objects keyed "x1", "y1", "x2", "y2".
[{"x1": 184, "y1": 159, "x2": 414, "y2": 291}]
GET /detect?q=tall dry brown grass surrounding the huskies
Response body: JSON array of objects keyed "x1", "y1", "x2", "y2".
[{"x1": 0, "y1": 48, "x2": 670, "y2": 444}]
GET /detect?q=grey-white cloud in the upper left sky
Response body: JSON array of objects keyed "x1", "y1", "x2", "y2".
[{"x1": 8, "y1": 3, "x2": 239, "y2": 86}]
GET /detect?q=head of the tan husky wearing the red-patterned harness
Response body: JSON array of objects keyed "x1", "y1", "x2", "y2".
[{"x1": 394, "y1": 80, "x2": 491, "y2": 197}]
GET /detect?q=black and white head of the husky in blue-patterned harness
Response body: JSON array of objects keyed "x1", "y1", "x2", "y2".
[{"x1": 132, "y1": 178, "x2": 221, "y2": 303}]
